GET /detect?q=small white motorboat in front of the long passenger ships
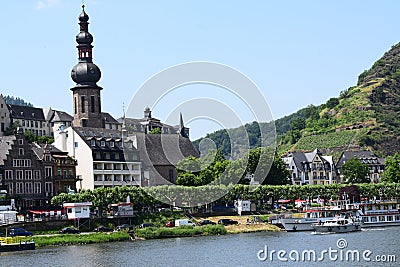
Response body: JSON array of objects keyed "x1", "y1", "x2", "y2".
[{"x1": 311, "y1": 215, "x2": 361, "y2": 233}]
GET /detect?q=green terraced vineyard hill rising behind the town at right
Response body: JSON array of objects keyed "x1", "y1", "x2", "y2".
[{"x1": 194, "y1": 43, "x2": 400, "y2": 156}]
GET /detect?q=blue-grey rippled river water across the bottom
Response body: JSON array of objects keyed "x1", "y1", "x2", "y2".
[{"x1": 0, "y1": 227, "x2": 400, "y2": 267}]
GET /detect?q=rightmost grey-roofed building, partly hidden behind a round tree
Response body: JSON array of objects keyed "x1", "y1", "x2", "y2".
[{"x1": 336, "y1": 150, "x2": 385, "y2": 183}]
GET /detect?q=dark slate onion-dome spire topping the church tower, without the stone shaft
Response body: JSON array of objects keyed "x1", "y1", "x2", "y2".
[{"x1": 71, "y1": 5, "x2": 101, "y2": 87}]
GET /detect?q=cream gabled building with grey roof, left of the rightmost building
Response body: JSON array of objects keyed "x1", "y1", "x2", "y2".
[{"x1": 282, "y1": 148, "x2": 340, "y2": 185}]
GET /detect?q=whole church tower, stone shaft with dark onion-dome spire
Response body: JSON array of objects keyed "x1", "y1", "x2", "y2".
[{"x1": 71, "y1": 5, "x2": 104, "y2": 128}]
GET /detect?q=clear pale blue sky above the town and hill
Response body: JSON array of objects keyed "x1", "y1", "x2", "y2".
[{"x1": 0, "y1": 0, "x2": 400, "y2": 139}]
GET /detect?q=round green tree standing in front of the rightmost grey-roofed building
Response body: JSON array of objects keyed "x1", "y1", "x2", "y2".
[{"x1": 342, "y1": 158, "x2": 370, "y2": 183}]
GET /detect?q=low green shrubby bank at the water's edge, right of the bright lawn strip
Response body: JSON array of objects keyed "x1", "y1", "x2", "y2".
[{"x1": 135, "y1": 225, "x2": 227, "y2": 239}]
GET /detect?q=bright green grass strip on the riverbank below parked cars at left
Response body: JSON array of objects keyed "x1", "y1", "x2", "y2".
[{"x1": 29, "y1": 232, "x2": 130, "y2": 247}]
